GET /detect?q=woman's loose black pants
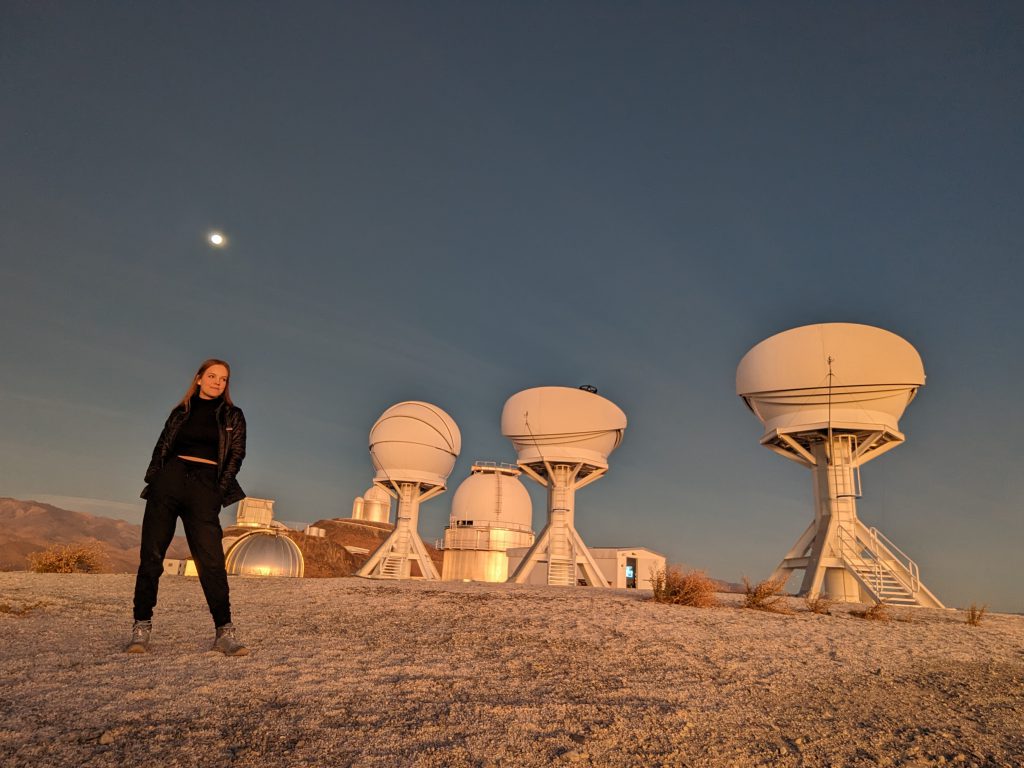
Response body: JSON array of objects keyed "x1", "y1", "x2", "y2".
[{"x1": 135, "y1": 459, "x2": 231, "y2": 627}]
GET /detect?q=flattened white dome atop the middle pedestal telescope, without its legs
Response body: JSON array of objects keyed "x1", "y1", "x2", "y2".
[{"x1": 502, "y1": 387, "x2": 626, "y2": 469}]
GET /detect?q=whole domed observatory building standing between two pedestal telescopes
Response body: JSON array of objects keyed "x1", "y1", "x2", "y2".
[{"x1": 441, "y1": 462, "x2": 534, "y2": 582}]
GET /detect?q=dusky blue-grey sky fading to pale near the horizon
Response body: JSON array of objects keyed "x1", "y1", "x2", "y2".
[{"x1": 0, "y1": 0, "x2": 1024, "y2": 611}]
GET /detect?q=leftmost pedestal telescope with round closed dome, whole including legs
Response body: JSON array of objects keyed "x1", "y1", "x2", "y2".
[{"x1": 356, "y1": 400, "x2": 462, "y2": 580}]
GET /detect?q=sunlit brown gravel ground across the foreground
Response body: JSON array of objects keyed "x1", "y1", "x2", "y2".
[{"x1": 0, "y1": 573, "x2": 1024, "y2": 768}]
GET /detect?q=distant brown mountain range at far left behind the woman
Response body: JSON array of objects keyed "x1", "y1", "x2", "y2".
[{"x1": 0, "y1": 498, "x2": 188, "y2": 573}]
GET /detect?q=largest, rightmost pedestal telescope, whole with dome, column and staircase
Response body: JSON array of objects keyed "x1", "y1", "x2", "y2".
[{"x1": 736, "y1": 323, "x2": 942, "y2": 607}]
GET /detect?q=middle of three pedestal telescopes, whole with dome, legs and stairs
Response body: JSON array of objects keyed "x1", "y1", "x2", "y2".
[{"x1": 502, "y1": 387, "x2": 626, "y2": 587}]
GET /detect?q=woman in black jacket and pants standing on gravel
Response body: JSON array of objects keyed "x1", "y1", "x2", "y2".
[{"x1": 127, "y1": 359, "x2": 249, "y2": 656}]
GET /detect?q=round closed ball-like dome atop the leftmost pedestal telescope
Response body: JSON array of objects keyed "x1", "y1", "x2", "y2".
[{"x1": 370, "y1": 400, "x2": 462, "y2": 485}]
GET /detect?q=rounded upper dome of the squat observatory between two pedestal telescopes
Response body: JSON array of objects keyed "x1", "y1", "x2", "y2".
[{"x1": 452, "y1": 466, "x2": 534, "y2": 528}]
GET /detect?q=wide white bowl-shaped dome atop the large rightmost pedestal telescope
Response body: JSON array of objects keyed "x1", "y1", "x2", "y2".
[{"x1": 736, "y1": 323, "x2": 925, "y2": 433}]
